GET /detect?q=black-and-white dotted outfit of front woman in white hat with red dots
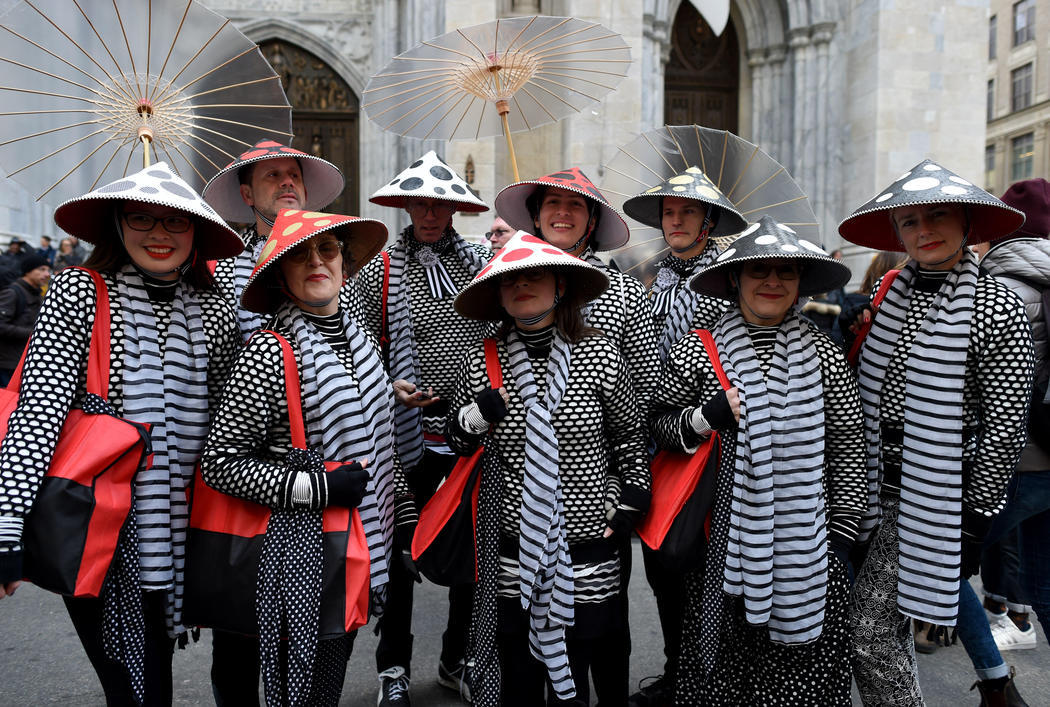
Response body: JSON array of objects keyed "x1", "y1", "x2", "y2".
[{"x1": 448, "y1": 327, "x2": 650, "y2": 704}]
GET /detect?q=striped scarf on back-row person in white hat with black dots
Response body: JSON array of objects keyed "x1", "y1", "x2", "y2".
[{"x1": 386, "y1": 226, "x2": 485, "y2": 473}]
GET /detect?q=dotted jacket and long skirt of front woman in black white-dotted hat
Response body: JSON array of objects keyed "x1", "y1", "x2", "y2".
[{"x1": 652, "y1": 317, "x2": 866, "y2": 707}]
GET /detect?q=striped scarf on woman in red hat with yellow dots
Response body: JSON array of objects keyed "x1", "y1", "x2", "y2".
[{"x1": 276, "y1": 303, "x2": 394, "y2": 592}]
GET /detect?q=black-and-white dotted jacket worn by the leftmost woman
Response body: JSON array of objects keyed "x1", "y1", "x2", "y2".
[{"x1": 0, "y1": 268, "x2": 239, "y2": 553}]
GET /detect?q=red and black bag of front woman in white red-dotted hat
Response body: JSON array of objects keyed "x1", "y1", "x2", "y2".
[{"x1": 412, "y1": 338, "x2": 503, "y2": 586}]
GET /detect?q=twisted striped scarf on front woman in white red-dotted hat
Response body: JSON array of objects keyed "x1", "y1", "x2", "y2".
[{"x1": 507, "y1": 331, "x2": 575, "y2": 700}]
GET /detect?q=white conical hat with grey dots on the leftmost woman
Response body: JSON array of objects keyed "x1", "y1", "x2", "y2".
[{"x1": 55, "y1": 162, "x2": 245, "y2": 261}]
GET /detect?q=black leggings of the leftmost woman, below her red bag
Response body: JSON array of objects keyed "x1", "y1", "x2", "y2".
[{"x1": 63, "y1": 591, "x2": 175, "y2": 707}]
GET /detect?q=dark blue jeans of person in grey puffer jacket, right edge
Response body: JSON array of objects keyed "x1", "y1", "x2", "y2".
[{"x1": 985, "y1": 470, "x2": 1050, "y2": 630}]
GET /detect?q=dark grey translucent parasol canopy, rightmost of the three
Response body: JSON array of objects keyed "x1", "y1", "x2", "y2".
[{"x1": 602, "y1": 125, "x2": 821, "y2": 282}]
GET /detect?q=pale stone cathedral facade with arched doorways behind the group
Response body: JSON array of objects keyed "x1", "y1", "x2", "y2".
[{"x1": 0, "y1": 0, "x2": 988, "y2": 269}]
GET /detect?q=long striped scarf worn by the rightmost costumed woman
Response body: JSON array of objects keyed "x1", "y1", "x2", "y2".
[{"x1": 859, "y1": 250, "x2": 978, "y2": 626}]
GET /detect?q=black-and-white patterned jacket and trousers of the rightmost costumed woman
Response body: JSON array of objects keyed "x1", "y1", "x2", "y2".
[{"x1": 849, "y1": 271, "x2": 1033, "y2": 705}]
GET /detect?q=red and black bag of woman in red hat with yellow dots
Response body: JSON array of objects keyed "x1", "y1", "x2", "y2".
[{"x1": 184, "y1": 330, "x2": 371, "y2": 639}]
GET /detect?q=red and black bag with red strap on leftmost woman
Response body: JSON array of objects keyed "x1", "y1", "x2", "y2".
[{"x1": 0, "y1": 268, "x2": 152, "y2": 597}]
